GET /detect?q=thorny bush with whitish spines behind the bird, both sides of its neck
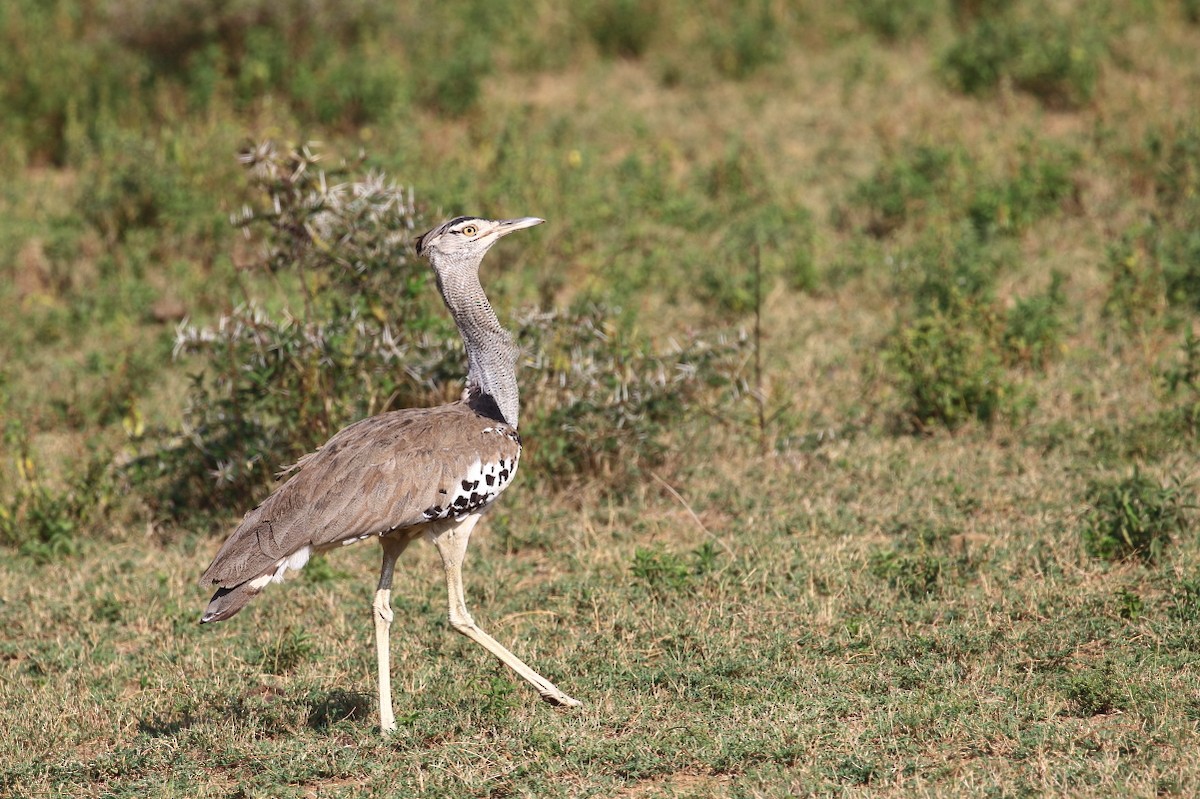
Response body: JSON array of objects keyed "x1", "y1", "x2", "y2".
[{"x1": 130, "y1": 143, "x2": 748, "y2": 518}]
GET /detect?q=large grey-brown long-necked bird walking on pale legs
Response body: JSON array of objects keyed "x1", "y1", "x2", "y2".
[{"x1": 200, "y1": 216, "x2": 580, "y2": 733}]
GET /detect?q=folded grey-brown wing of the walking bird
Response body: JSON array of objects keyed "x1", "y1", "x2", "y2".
[{"x1": 200, "y1": 403, "x2": 520, "y2": 585}]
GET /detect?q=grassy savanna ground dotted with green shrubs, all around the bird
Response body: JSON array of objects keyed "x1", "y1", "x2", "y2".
[{"x1": 0, "y1": 0, "x2": 1200, "y2": 798}]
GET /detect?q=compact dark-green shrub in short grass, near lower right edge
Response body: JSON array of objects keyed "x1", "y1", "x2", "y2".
[{"x1": 1082, "y1": 469, "x2": 1195, "y2": 563}]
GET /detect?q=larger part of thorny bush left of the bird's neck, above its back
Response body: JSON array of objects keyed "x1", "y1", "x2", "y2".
[{"x1": 131, "y1": 144, "x2": 436, "y2": 516}]
